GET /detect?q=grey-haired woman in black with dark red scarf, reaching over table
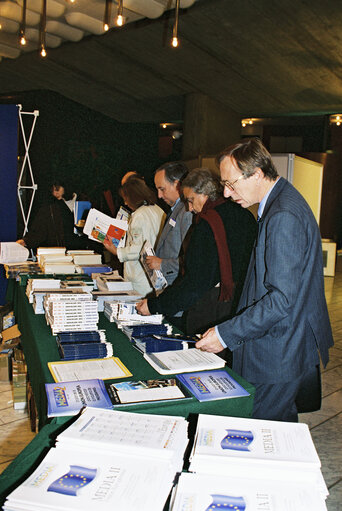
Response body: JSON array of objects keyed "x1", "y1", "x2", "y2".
[{"x1": 137, "y1": 169, "x2": 257, "y2": 340}]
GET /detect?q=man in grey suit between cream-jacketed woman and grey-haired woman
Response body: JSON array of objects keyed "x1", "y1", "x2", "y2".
[{"x1": 146, "y1": 162, "x2": 192, "y2": 285}]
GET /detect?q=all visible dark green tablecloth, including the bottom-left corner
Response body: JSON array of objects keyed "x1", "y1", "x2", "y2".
[{"x1": 0, "y1": 281, "x2": 255, "y2": 508}]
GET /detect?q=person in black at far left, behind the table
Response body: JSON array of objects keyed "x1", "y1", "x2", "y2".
[{"x1": 17, "y1": 181, "x2": 86, "y2": 249}]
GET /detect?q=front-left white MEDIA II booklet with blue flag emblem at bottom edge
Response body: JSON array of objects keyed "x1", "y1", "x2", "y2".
[{"x1": 4, "y1": 447, "x2": 175, "y2": 511}]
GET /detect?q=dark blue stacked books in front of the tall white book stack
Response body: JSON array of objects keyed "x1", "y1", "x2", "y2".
[{"x1": 56, "y1": 330, "x2": 113, "y2": 360}]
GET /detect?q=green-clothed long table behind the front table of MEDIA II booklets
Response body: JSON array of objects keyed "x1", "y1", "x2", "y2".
[{"x1": 9, "y1": 282, "x2": 254, "y2": 428}]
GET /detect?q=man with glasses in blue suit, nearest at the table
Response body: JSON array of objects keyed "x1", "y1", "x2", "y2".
[{"x1": 196, "y1": 139, "x2": 333, "y2": 421}]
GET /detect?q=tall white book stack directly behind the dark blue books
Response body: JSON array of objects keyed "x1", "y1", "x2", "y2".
[{"x1": 44, "y1": 291, "x2": 99, "y2": 335}]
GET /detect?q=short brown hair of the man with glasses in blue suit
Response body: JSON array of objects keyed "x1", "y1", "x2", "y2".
[{"x1": 216, "y1": 138, "x2": 278, "y2": 181}]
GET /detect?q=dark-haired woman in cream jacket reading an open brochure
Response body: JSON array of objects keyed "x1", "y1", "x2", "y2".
[{"x1": 103, "y1": 176, "x2": 165, "y2": 296}]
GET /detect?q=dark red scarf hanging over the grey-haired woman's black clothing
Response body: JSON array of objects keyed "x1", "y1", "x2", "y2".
[{"x1": 195, "y1": 197, "x2": 234, "y2": 302}]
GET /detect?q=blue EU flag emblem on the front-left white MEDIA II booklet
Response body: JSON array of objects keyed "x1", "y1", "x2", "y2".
[{"x1": 47, "y1": 465, "x2": 97, "y2": 497}]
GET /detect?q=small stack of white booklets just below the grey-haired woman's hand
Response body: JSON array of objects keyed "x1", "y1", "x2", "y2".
[{"x1": 104, "y1": 301, "x2": 163, "y2": 328}]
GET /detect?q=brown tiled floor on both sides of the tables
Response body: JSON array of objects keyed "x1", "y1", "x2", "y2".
[{"x1": 0, "y1": 256, "x2": 342, "y2": 511}]
